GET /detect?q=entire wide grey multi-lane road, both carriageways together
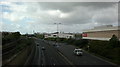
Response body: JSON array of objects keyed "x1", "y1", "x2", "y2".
[{"x1": 29, "y1": 39, "x2": 117, "y2": 67}]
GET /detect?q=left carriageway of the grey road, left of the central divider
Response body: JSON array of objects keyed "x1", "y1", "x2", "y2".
[{"x1": 32, "y1": 39, "x2": 69, "y2": 66}]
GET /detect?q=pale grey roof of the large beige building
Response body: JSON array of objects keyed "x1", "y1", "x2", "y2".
[{"x1": 83, "y1": 25, "x2": 120, "y2": 32}]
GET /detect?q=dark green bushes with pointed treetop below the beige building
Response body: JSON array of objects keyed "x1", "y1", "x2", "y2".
[{"x1": 89, "y1": 35, "x2": 120, "y2": 64}]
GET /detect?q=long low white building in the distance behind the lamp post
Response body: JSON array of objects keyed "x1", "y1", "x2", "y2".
[{"x1": 44, "y1": 33, "x2": 74, "y2": 38}]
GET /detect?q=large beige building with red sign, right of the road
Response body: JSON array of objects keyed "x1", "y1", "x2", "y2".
[{"x1": 82, "y1": 25, "x2": 120, "y2": 41}]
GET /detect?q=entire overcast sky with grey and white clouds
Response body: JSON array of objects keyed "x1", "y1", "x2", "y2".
[{"x1": 0, "y1": 2, "x2": 118, "y2": 33}]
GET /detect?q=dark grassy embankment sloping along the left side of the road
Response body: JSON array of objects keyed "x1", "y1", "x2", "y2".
[{"x1": 2, "y1": 38, "x2": 35, "y2": 65}]
